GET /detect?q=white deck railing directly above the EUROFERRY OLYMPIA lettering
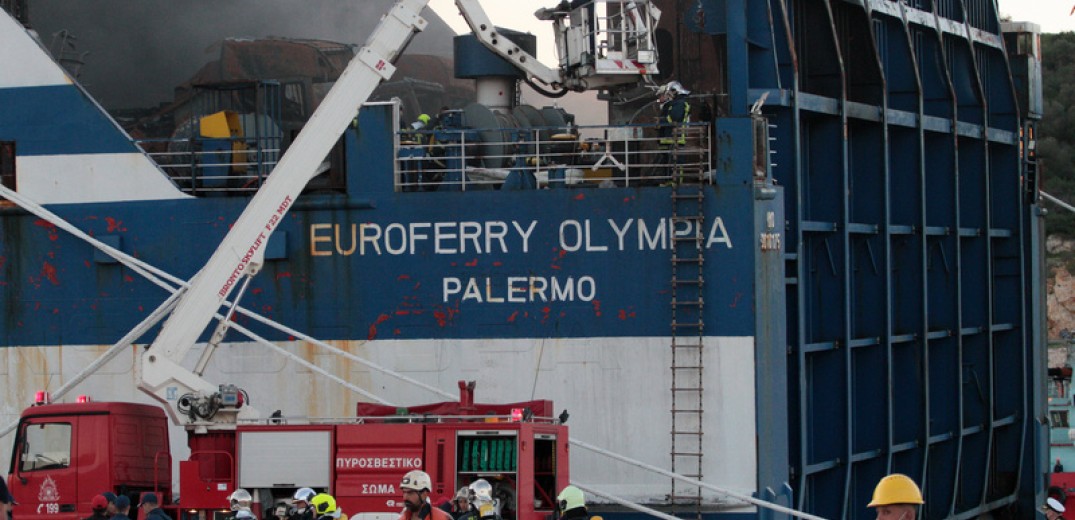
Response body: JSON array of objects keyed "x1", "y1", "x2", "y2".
[{"x1": 396, "y1": 124, "x2": 713, "y2": 191}]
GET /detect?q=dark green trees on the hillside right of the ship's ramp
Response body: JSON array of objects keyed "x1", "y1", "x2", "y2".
[{"x1": 1037, "y1": 32, "x2": 1075, "y2": 239}]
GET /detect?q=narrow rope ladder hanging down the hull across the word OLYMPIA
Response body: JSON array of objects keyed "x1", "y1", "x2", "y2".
[{"x1": 669, "y1": 127, "x2": 707, "y2": 520}]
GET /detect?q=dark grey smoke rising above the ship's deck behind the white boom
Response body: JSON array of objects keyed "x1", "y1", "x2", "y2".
[{"x1": 30, "y1": 0, "x2": 454, "y2": 110}]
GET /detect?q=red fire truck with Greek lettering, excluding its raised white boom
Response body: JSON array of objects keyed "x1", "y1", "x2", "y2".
[{"x1": 9, "y1": 381, "x2": 568, "y2": 520}]
